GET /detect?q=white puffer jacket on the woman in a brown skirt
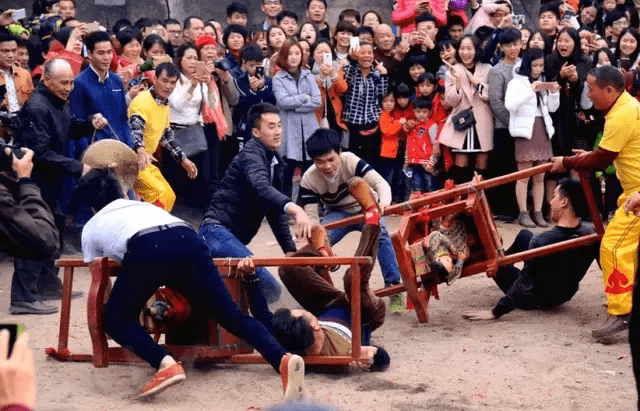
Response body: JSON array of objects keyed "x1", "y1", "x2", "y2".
[{"x1": 504, "y1": 73, "x2": 560, "y2": 140}]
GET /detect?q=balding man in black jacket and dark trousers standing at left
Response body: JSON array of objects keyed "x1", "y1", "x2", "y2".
[{"x1": 10, "y1": 59, "x2": 107, "y2": 314}]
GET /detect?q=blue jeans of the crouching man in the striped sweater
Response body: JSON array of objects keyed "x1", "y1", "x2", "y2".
[{"x1": 321, "y1": 209, "x2": 400, "y2": 287}]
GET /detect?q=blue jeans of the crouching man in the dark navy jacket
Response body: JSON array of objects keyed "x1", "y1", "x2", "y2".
[{"x1": 198, "y1": 224, "x2": 282, "y2": 303}]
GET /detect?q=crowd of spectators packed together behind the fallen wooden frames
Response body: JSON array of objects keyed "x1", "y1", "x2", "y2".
[{"x1": 0, "y1": 0, "x2": 640, "y2": 311}]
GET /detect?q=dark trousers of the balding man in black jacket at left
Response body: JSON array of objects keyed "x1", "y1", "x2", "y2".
[{"x1": 11, "y1": 212, "x2": 66, "y2": 302}]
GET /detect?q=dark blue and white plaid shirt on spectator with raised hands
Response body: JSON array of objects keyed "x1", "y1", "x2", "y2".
[{"x1": 342, "y1": 63, "x2": 389, "y2": 126}]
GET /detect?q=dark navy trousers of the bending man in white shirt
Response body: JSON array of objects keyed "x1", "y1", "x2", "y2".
[{"x1": 104, "y1": 227, "x2": 286, "y2": 371}]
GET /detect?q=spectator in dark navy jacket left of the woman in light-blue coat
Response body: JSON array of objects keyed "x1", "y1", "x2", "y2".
[{"x1": 233, "y1": 43, "x2": 276, "y2": 150}]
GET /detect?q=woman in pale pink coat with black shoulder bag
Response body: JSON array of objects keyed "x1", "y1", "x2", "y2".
[{"x1": 439, "y1": 34, "x2": 493, "y2": 184}]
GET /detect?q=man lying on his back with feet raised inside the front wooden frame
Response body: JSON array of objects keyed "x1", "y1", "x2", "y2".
[{"x1": 238, "y1": 177, "x2": 390, "y2": 371}]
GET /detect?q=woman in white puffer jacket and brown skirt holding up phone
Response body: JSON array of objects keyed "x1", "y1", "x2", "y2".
[{"x1": 504, "y1": 48, "x2": 560, "y2": 228}]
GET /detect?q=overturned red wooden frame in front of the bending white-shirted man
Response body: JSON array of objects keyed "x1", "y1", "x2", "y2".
[{"x1": 46, "y1": 257, "x2": 372, "y2": 367}]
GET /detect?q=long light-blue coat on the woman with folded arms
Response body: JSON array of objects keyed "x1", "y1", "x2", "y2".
[{"x1": 273, "y1": 69, "x2": 322, "y2": 161}]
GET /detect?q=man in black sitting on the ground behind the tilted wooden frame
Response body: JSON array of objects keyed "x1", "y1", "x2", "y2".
[{"x1": 463, "y1": 179, "x2": 600, "y2": 321}]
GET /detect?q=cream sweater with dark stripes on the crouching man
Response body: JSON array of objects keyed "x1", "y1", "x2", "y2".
[{"x1": 298, "y1": 153, "x2": 391, "y2": 214}]
